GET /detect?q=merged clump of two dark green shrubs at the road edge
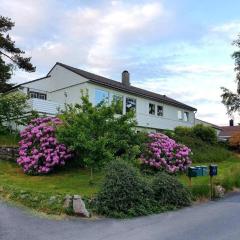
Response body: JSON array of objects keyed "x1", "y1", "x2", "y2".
[{"x1": 94, "y1": 160, "x2": 191, "y2": 218}]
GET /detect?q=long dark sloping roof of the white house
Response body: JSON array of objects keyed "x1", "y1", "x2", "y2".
[{"x1": 53, "y1": 62, "x2": 197, "y2": 111}]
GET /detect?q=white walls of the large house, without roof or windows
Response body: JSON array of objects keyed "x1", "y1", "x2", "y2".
[{"x1": 18, "y1": 65, "x2": 195, "y2": 131}]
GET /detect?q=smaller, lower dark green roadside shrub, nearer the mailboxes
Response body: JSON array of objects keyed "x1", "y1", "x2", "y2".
[{"x1": 152, "y1": 172, "x2": 191, "y2": 207}]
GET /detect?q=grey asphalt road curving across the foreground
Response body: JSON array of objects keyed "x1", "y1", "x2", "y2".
[{"x1": 0, "y1": 194, "x2": 240, "y2": 240}]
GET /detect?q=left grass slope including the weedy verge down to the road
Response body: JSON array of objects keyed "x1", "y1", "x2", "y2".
[{"x1": 0, "y1": 160, "x2": 103, "y2": 215}]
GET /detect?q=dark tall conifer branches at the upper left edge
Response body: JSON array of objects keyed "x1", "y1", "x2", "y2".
[{"x1": 0, "y1": 16, "x2": 36, "y2": 92}]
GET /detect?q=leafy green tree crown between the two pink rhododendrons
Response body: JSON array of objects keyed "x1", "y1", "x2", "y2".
[{"x1": 57, "y1": 96, "x2": 145, "y2": 171}]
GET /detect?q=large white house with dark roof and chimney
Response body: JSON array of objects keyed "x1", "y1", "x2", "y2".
[{"x1": 8, "y1": 63, "x2": 197, "y2": 131}]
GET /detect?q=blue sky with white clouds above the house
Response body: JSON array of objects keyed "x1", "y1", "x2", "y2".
[{"x1": 0, "y1": 0, "x2": 240, "y2": 125}]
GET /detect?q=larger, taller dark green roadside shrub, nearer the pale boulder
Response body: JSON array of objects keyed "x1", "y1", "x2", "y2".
[{"x1": 95, "y1": 160, "x2": 158, "y2": 217}]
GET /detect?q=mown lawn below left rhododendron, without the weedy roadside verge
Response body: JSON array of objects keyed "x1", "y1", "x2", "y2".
[{"x1": 0, "y1": 160, "x2": 102, "y2": 197}]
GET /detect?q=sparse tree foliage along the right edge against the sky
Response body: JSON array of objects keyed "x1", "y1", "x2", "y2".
[{"x1": 221, "y1": 34, "x2": 240, "y2": 115}]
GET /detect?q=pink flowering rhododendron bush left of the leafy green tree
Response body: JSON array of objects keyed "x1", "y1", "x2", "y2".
[{"x1": 17, "y1": 117, "x2": 71, "y2": 175}]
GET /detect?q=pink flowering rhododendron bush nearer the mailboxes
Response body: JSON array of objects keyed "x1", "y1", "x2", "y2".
[{"x1": 141, "y1": 133, "x2": 192, "y2": 173}]
